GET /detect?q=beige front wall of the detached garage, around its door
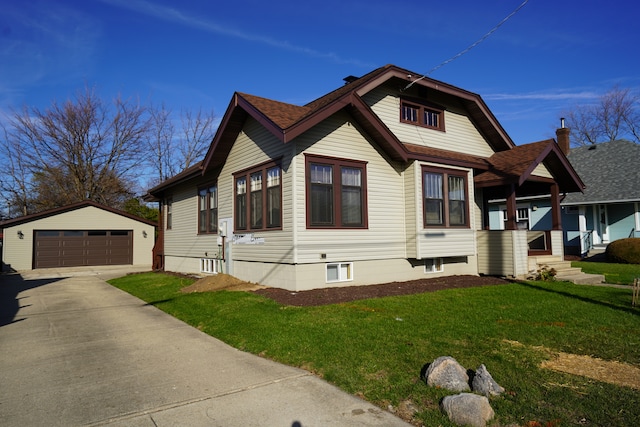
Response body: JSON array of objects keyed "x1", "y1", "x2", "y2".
[{"x1": 2, "y1": 206, "x2": 155, "y2": 271}]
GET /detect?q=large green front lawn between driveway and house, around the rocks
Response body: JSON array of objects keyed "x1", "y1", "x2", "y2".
[{"x1": 111, "y1": 273, "x2": 640, "y2": 426}]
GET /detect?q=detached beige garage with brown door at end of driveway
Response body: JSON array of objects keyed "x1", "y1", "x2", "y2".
[{"x1": 0, "y1": 201, "x2": 155, "y2": 271}]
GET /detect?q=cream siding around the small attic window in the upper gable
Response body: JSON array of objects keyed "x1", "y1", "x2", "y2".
[{"x1": 363, "y1": 86, "x2": 494, "y2": 157}]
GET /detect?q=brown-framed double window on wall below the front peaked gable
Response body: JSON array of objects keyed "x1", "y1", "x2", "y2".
[{"x1": 306, "y1": 155, "x2": 367, "y2": 228}]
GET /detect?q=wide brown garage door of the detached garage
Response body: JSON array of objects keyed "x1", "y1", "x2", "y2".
[{"x1": 33, "y1": 230, "x2": 133, "y2": 268}]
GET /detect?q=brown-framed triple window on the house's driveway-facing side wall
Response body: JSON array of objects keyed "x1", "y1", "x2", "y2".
[{"x1": 234, "y1": 162, "x2": 282, "y2": 231}]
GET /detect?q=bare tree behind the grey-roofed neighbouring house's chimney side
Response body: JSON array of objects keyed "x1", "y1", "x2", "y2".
[{"x1": 564, "y1": 86, "x2": 640, "y2": 146}]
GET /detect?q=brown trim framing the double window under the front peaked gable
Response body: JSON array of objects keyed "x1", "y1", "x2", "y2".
[{"x1": 305, "y1": 154, "x2": 369, "y2": 230}]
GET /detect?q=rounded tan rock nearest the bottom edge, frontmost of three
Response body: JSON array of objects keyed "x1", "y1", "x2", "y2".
[{"x1": 440, "y1": 393, "x2": 495, "y2": 427}]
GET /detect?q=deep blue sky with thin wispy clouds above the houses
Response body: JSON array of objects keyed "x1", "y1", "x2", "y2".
[{"x1": 0, "y1": 0, "x2": 640, "y2": 144}]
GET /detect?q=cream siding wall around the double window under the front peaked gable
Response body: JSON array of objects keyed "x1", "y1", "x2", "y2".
[{"x1": 294, "y1": 113, "x2": 406, "y2": 263}]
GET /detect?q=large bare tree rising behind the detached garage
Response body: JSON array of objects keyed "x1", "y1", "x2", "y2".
[{"x1": 3, "y1": 88, "x2": 150, "y2": 215}]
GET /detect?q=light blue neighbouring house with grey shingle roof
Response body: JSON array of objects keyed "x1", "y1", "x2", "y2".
[{"x1": 561, "y1": 140, "x2": 640, "y2": 256}]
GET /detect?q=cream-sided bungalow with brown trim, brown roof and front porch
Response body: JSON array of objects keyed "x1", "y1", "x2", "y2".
[{"x1": 148, "y1": 65, "x2": 583, "y2": 291}]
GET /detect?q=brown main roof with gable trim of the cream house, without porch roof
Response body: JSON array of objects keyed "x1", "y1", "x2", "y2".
[{"x1": 202, "y1": 65, "x2": 515, "y2": 173}]
